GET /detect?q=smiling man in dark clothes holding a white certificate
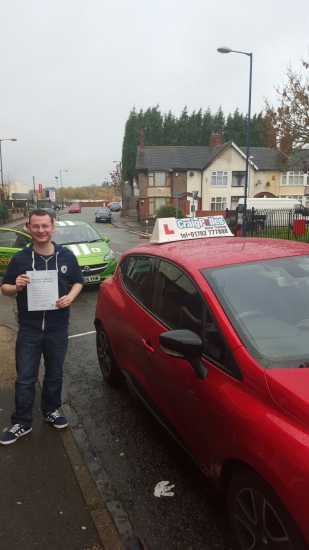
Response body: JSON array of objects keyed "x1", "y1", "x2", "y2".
[{"x1": 0, "y1": 208, "x2": 83, "y2": 445}]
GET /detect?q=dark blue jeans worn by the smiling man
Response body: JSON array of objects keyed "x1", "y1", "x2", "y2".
[{"x1": 11, "y1": 325, "x2": 68, "y2": 428}]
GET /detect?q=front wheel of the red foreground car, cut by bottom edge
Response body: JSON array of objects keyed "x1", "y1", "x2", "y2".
[{"x1": 227, "y1": 470, "x2": 307, "y2": 550}]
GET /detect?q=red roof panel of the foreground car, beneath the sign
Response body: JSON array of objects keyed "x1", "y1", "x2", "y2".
[{"x1": 123, "y1": 237, "x2": 309, "y2": 271}]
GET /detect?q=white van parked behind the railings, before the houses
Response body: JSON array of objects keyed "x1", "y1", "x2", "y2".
[{"x1": 237, "y1": 197, "x2": 304, "y2": 231}]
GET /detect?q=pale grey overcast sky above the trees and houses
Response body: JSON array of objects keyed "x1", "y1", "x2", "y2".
[{"x1": 0, "y1": 0, "x2": 309, "y2": 191}]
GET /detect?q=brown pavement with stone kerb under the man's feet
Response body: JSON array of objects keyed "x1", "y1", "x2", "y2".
[{"x1": 0, "y1": 212, "x2": 141, "y2": 550}]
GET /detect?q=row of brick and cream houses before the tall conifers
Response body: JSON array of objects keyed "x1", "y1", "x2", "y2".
[{"x1": 136, "y1": 133, "x2": 309, "y2": 218}]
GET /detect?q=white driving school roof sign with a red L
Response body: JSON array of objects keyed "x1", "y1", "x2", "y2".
[{"x1": 150, "y1": 216, "x2": 233, "y2": 243}]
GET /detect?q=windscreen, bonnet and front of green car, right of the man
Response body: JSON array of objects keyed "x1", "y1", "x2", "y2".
[{"x1": 52, "y1": 221, "x2": 117, "y2": 284}]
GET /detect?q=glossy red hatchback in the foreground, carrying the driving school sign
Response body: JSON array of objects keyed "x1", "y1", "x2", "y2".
[{"x1": 95, "y1": 220, "x2": 309, "y2": 550}]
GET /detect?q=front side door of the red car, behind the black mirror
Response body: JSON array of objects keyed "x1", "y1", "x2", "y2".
[{"x1": 139, "y1": 260, "x2": 241, "y2": 471}]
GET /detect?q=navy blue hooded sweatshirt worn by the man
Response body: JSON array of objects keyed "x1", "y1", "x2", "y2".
[{"x1": 2, "y1": 243, "x2": 83, "y2": 331}]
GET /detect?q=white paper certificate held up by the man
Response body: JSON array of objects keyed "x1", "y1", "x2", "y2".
[{"x1": 26, "y1": 269, "x2": 59, "y2": 311}]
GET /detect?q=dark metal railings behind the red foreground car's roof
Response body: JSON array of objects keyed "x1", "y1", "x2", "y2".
[{"x1": 226, "y1": 206, "x2": 309, "y2": 243}]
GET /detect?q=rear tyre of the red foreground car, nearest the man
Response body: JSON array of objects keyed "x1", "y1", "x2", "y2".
[{"x1": 96, "y1": 323, "x2": 122, "y2": 386}]
